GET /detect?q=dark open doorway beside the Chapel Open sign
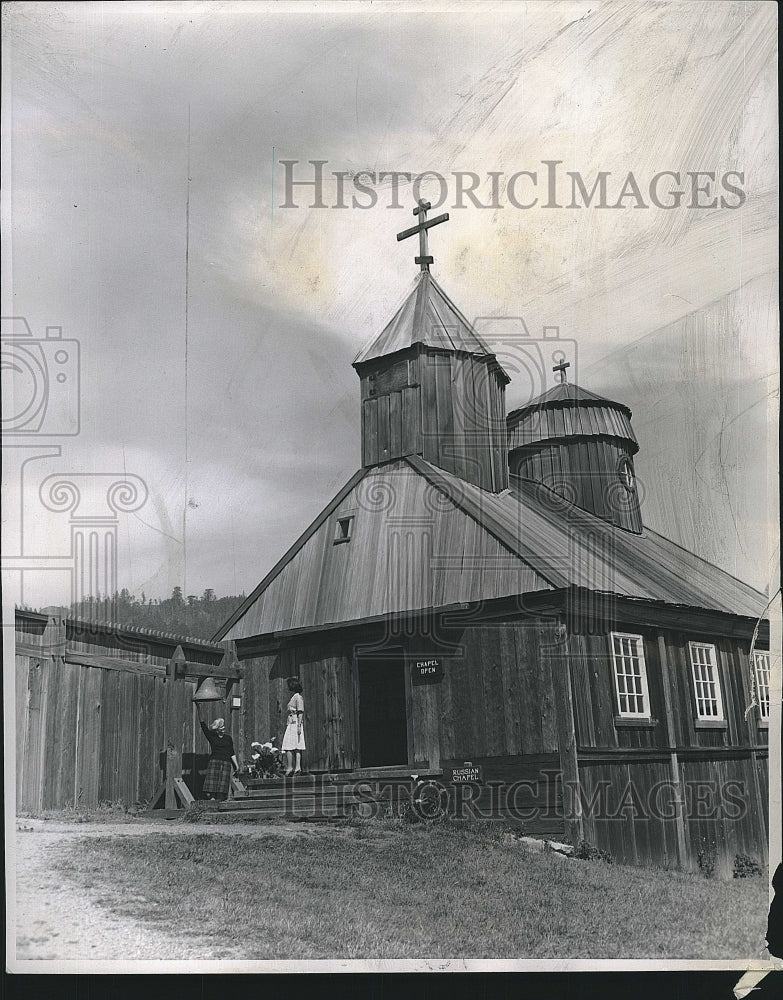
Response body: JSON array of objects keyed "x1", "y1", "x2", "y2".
[{"x1": 358, "y1": 649, "x2": 408, "y2": 767}]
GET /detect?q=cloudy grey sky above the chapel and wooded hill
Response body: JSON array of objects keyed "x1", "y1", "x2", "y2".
[{"x1": 2, "y1": 2, "x2": 778, "y2": 606}]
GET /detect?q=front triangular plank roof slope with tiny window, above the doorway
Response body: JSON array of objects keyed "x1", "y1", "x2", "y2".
[{"x1": 226, "y1": 462, "x2": 548, "y2": 639}]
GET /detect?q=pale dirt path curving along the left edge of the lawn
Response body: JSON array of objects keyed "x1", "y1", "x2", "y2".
[{"x1": 8, "y1": 819, "x2": 330, "y2": 962}]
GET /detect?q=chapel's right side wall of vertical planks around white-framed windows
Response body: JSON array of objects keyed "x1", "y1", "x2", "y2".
[{"x1": 569, "y1": 622, "x2": 768, "y2": 877}]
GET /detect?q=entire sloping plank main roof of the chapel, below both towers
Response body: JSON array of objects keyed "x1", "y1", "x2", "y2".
[{"x1": 216, "y1": 456, "x2": 766, "y2": 639}]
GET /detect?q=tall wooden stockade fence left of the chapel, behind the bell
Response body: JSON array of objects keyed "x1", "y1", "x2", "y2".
[{"x1": 15, "y1": 611, "x2": 244, "y2": 812}]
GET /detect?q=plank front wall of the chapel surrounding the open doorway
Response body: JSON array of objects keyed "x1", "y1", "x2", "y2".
[{"x1": 243, "y1": 618, "x2": 558, "y2": 771}]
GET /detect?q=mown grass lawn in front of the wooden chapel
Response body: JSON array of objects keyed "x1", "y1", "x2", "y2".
[{"x1": 49, "y1": 821, "x2": 768, "y2": 960}]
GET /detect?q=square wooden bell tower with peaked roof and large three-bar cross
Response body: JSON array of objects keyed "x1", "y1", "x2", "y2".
[{"x1": 353, "y1": 211, "x2": 510, "y2": 493}]
